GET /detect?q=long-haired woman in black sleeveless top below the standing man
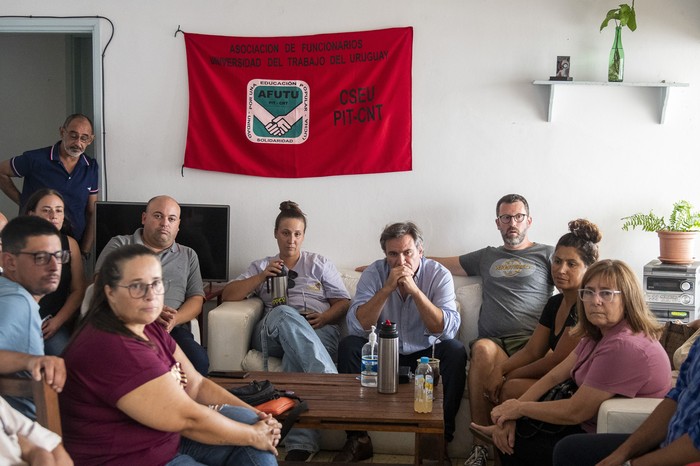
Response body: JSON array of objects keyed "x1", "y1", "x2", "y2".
[{"x1": 23, "y1": 188, "x2": 86, "y2": 356}]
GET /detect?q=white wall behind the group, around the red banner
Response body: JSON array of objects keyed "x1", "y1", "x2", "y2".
[{"x1": 3, "y1": 0, "x2": 700, "y2": 276}]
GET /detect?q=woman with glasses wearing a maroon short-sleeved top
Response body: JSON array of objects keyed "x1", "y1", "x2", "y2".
[{"x1": 60, "y1": 245, "x2": 281, "y2": 466}]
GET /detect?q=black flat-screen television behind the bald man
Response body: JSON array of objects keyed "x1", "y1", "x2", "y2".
[{"x1": 95, "y1": 201, "x2": 229, "y2": 282}]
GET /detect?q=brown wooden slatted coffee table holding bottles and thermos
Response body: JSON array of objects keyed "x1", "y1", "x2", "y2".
[{"x1": 212, "y1": 372, "x2": 445, "y2": 465}]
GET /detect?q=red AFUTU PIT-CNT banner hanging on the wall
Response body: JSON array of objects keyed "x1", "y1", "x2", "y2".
[{"x1": 184, "y1": 27, "x2": 413, "y2": 178}]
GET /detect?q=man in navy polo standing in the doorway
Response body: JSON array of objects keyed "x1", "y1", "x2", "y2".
[{"x1": 0, "y1": 113, "x2": 99, "y2": 257}]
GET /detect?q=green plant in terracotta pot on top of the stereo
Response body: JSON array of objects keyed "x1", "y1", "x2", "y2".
[{"x1": 622, "y1": 201, "x2": 700, "y2": 264}]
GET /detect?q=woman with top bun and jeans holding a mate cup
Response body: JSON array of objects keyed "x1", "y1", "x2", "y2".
[{"x1": 222, "y1": 201, "x2": 350, "y2": 461}]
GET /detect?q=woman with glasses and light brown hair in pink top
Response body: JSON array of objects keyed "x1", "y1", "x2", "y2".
[{"x1": 473, "y1": 260, "x2": 671, "y2": 466}]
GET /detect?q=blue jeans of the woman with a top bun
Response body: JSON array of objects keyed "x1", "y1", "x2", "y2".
[{"x1": 252, "y1": 306, "x2": 340, "y2": 452}]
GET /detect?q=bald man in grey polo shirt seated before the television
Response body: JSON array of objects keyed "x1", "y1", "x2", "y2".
[{"x1": 95, "y1": 196, "x2": 209, "y2": 376}]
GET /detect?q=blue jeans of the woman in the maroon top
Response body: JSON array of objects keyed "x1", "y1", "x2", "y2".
[{"x1": 166, "y1": 406, "x2": 277, "y2": 466}]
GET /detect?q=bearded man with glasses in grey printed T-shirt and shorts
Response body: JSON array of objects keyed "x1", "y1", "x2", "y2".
[{"x1": 433, "y1": 194, "x2": 554, "y2": 466}]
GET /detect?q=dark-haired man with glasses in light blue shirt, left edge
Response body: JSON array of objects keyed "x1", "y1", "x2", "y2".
[{"x1": 0, "y1": 216, "x2": 70, "y2": 419}]
